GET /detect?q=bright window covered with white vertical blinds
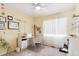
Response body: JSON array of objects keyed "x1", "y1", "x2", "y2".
[{"x1": 43, "y1": 17, "x2": 67, "y2": 37}]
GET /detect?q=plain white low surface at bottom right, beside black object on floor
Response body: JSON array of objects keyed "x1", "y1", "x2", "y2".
[{"x1": 68, "y1": 36, "x2": 79, "y2": 56}]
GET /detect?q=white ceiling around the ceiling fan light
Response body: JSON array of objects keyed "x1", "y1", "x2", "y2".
[{"x1": 5, "y1": 3, "x2": 75, "y2": 16}]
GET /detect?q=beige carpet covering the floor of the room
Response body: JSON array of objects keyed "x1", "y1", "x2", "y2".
[{"x1": 7, "y1": 46, "x2": 66, "y2": 56}]
